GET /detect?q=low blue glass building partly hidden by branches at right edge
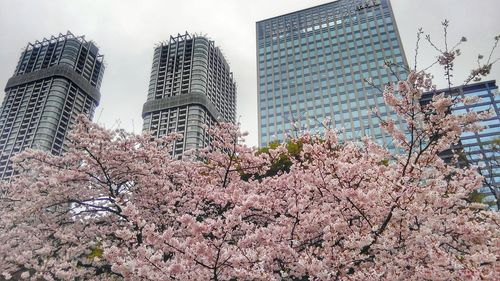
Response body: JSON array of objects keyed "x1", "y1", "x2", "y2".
[{"x1": 421, "y1": 80, "x2": 500, "y2": 207}]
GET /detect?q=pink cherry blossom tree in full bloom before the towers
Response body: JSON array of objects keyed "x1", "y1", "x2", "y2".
[{"x1": 0, "y1": 26, "x2": 500, "y2": 280}]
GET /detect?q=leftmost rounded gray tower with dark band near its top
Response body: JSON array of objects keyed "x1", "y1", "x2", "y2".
[{"x1": 0, "y1": 31, "x2": 104, "y2": 179}]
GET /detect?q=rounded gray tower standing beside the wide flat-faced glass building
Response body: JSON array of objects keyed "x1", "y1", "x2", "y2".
[{"x1": 142, "y1": 33, "x2": 236, "y2": 156}]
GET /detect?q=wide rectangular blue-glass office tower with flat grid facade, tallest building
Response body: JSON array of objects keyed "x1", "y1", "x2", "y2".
[{"x1": 256, "y1": 0, "x2": 408, "y2": 147}]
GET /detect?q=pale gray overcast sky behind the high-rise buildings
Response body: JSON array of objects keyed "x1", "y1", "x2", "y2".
[{"x1": 0, "y1": 0, "x2": 500, "y2": 146}]
